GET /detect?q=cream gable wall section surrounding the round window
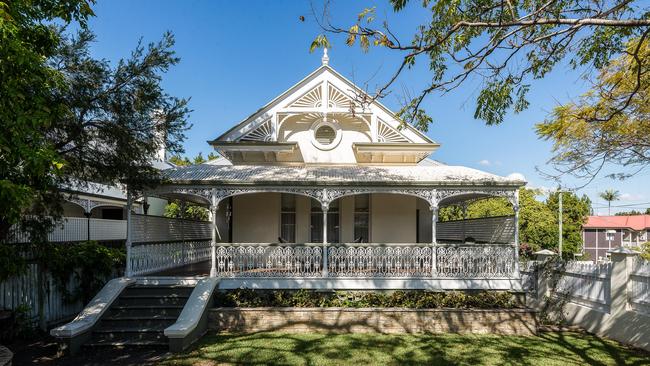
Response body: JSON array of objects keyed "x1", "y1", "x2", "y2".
[{"x1": 279, "y1": 115, "x2": 370, "y2": 164}]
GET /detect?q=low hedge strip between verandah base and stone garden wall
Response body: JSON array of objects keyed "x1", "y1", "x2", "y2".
[{"x1": 216, "y1": 289, "x2": 517, "y2": 309}]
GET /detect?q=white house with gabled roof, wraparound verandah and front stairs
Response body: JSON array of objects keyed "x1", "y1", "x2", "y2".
[{"x1": 51, "y1": 53, "x2": 526, "y2": 350}]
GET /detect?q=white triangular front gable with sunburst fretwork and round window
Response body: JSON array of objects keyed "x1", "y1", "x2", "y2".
[{"x1": 210, "y1": 65, "x2": 438, "y2": 164}]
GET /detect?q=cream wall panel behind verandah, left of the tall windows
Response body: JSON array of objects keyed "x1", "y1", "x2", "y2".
[{"x1": 232, "y1": 193, "x2": 280, "y2": 243}]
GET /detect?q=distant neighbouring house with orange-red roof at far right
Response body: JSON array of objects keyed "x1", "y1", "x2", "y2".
[{"x1": 582, "y1": 215, "x2": 650, "y2": 261}]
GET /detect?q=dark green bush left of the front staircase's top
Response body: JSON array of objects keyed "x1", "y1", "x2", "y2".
[{"x1": 47, "y1": 241, "x2": 126, "y2": 304}]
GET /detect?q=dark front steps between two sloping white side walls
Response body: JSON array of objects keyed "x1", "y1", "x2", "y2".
[{"x1": 84, "y1": 284, "x2": 194, "y2": 347}]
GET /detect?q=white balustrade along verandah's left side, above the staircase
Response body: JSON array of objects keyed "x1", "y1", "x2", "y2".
[{"x1": 131, "y1": 240, "x2": 210, "y2": 276}]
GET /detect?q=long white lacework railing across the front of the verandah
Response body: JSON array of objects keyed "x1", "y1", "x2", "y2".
[{"x1": 210, "y1": 243, "x2": 517, "y2": 279}]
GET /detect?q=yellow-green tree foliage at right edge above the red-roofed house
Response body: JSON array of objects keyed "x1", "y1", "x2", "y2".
[{"x1": 536, "y1": 38, "x2": 650, "y2": 182}]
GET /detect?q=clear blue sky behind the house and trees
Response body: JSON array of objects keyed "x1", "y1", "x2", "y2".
[{"x1": 82, "y1": 0, "x2": 650, "y2": 214}]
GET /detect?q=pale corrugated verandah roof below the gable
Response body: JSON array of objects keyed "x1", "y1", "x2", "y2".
[{"x1": 162, "y1": 164, "x2": 526, "y2": 187}]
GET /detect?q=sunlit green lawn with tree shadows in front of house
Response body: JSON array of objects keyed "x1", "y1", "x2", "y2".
[{"x1": 164, "y1": 332, "x2": 650, "y2": 366}]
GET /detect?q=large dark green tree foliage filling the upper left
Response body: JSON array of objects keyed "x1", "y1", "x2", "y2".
[{"x1": 0, "y1": 0, "x2": 189, "y2": 244}]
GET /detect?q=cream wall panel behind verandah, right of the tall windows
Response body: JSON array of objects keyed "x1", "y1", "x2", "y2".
[{"x1": 370, "y1": 193, "x2": 417, "y2": 243}]
